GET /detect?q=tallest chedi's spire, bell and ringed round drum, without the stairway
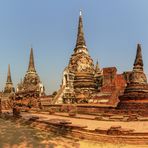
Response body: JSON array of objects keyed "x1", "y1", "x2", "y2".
[{"x1": 68, "y1": 11, "x2": 97, "y2": 102}]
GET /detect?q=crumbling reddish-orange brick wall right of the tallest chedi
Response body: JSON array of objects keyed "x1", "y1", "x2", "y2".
[{"x1": 98, "y1": 67, "x2": 127, "y2": 105}]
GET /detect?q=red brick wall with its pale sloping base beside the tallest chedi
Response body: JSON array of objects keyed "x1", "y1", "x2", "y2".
[{"x1": 92, "y1": 67, "x2": 126, "y2": 105}]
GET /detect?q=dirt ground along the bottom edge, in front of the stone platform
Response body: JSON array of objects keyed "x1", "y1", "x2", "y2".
[{"x1": 0, "y1": 119, "x2": 147, "y2": 148}]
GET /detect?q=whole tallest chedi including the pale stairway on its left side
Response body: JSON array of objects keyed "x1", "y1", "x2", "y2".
[{"x1": 54, "y1": 11, "x2": 99, "y2": 103}]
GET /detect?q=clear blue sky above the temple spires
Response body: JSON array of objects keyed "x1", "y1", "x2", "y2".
[{"x1": 0, "y1": 0, "x2": 148, "y2": 94}]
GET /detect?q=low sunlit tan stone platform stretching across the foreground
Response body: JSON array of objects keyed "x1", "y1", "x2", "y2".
[{"x1": 22, "y1": 113, "x2": 148, "y2": 145}]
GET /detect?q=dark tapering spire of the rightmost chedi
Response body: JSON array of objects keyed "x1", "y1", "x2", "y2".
[{"x1": 133, "y1": 44, "x2": 143, "y2": 71}]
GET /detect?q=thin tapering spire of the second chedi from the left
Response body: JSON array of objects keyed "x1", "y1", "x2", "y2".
[{"x1": 28, "y1": 48, "x2": 36, "y2": 72}]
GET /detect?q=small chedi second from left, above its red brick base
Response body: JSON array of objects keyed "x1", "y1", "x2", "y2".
[{"x1": 16, "y1": 48, "x2": 44, "y2": 98}]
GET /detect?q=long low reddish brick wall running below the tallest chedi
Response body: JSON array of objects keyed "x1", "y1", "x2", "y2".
[{"x1": 43, "y1": 104, "x2": 148, "y2": 117}]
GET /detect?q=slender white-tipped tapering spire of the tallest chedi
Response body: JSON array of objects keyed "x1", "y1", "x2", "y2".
[{"x1": 75, "y1": 10, "x2": 86, "y2": 49}]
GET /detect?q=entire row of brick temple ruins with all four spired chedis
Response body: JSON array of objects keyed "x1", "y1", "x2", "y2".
[{"x1": 1, "y1": 13, "x2": 148, "y2": 117}]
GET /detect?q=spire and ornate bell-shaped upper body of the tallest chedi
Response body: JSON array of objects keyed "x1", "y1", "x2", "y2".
[{"x1": 68, "y1": 11, "x2": 95, "y2": 74}]
